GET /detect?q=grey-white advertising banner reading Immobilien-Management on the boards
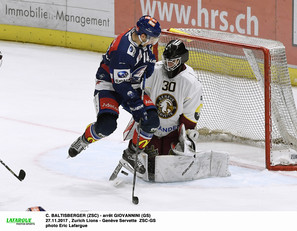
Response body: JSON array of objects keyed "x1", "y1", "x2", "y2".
[{"x1": 0, "y1": 0, "x2": 114, "y2": 37}]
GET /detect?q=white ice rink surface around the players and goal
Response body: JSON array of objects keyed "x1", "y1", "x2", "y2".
[{"x1": 0, "y1": 41, "x2": 297, "y2": 229}]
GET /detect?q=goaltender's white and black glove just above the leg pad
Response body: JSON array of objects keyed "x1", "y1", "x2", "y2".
[{"x1": 171, "y1": 124, "x2": 199, "y2": 156}]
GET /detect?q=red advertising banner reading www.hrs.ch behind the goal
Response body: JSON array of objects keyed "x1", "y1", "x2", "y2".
[{"x1": 115, "y1": 0, "x2": 297, "y2": 66}]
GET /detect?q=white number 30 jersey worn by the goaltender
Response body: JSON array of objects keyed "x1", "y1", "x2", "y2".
[{"x1": 145, "y1": 61, "x2": 203, "y2": 137}]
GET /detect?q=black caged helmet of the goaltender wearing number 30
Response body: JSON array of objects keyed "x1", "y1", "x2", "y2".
[{"x1": 163, "y1": 40, "x2": 189, "y2": 78}]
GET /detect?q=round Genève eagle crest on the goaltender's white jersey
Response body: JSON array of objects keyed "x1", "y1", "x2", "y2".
[{"x1": 156, "y1": 94, "x2": 177, "y2": 119}]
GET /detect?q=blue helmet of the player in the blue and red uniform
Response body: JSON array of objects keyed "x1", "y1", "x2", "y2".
[{"x1": 136, "y1": 15, "x2": 161, "y2": 45}]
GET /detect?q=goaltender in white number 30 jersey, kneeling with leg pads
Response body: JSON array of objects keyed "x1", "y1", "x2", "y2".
[{"x1": 108, "y1": 40, "x2": 230, "y2": 182}]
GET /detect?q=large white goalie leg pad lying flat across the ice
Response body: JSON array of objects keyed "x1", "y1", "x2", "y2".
[{"x1": 155, "y1": 151, "x2": 231, "y2": 182}]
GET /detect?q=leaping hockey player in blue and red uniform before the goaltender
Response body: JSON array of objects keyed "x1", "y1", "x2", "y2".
[{"x1": 68, "y1": 15, "x2": 161, "y2": 174}]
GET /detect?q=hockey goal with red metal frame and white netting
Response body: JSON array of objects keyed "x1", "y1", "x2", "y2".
[{"x1": 154, "y1": 28, "x2": 297, "y2": 171}]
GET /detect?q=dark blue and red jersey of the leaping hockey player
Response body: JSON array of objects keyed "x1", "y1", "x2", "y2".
[{"x1": 96, "y1": 28, "x2": 156, "y2": 102}]
